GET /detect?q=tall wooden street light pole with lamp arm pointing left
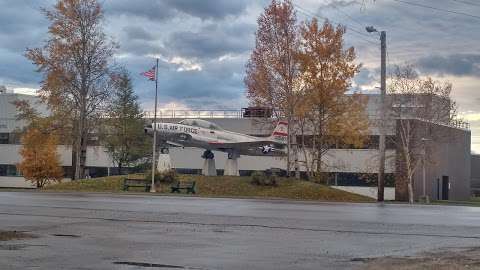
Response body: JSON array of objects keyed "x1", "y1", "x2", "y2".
[{"x1": 365, "y1": 26, "x2": 387, "y2": 202}]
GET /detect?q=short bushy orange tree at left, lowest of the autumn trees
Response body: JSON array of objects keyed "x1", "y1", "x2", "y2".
[{"x1": 17, "y1": 127, "x2": 63, "y2": 188}]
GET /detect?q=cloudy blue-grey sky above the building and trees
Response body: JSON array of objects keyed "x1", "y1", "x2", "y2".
[{"x1": 0, "y1": 0, "x2": 480, "y2": 153}]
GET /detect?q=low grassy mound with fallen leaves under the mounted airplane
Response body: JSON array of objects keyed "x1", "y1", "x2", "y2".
[{"x1": 43, "y1": 175, "x2": 373, "y2": 202}]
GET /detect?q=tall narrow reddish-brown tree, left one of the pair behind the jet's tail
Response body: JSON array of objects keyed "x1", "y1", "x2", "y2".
[{"x1": 244, "y1": 0, "x2": 300, "y2": 172}]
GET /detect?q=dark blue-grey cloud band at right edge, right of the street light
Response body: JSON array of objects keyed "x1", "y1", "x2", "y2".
[{"x1": 417, "y1": 54, "x2": 480, "y2": 76}]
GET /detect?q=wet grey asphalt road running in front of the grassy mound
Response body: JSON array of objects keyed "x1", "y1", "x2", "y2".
[{"x1": 0, "y1": 192, "x2": 480, "y2": 269}]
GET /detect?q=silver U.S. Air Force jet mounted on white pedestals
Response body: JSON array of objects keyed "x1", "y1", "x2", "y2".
[{"x1": 145, "y1": 119, "x2": 288, "y2": 159}]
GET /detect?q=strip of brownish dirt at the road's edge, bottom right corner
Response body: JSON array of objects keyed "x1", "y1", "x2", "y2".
[{"x1": 362, "y1": 247, "x2": 480, "y2": 270}]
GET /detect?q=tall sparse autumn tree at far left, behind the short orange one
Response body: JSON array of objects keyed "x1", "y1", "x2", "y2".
[{"x1": 26, "y1": 0, "x2": 117, "y2": 179}]
